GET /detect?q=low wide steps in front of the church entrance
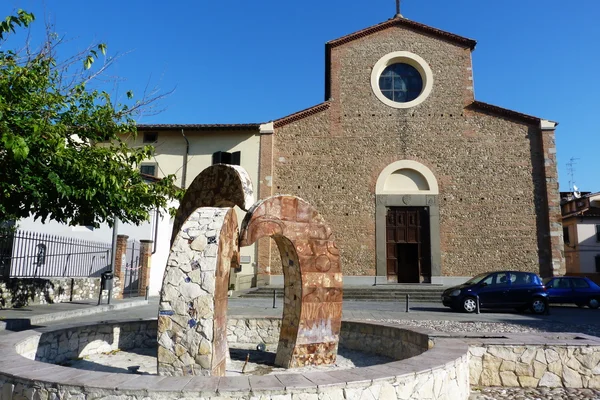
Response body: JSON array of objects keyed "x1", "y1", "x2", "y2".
[{"x1": 237, "y1": 284, "x2": 447, "y2": 303}]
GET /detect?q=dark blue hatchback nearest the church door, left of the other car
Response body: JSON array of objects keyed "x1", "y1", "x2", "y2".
[{"x1": 442, "y1": 271, "x2": 548, "y2": 314}]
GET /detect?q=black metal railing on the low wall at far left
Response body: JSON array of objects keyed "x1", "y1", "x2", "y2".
[{"x1": 0, "y1": 230, "x2": 111, "y2": 278}]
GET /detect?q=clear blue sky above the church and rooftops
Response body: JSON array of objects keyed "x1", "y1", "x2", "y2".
[{"x1": 0, "y1": 0, "x2": 600, "y2": 191}]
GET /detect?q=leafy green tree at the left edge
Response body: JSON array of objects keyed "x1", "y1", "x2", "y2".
[{"x1": 0, "y1": 10, "x2": 181, "y2": 226}]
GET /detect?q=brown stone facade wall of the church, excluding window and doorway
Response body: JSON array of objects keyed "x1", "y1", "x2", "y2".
[{"x1": 261, "y1": 22, "x2": 560, "y2": 276}]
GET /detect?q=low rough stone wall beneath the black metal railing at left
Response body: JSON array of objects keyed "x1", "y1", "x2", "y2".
[{"x1": 0, "y1": 277, "x2": 121, "y2": 308}]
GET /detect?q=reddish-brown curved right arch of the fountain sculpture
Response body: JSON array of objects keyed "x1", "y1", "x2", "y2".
[{"x1": 240, "y1": 196, "x2": 343, "y2": 368}]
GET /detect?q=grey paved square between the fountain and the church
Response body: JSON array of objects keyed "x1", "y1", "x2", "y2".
[{"x1": 0, "y1": 297, "x2": 600, "y2": 336}]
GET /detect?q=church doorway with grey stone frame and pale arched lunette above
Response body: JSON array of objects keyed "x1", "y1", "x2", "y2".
[{"x1": 375, "y1": 160, "x2": 441, "y2": 283}]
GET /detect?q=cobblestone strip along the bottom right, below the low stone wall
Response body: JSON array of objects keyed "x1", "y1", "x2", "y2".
[{"x1": 469, "y1": 387, "x2": 600, "y2": 400}]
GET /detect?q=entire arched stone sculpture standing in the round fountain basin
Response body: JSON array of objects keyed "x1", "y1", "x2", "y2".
[{"x1": 158, "y1": 164, "x2": 342, "y2": 376}]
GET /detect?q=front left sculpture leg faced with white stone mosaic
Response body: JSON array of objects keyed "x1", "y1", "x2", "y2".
[{"x1": 158, "y1": 207, "x2": 239, "y2": 376}]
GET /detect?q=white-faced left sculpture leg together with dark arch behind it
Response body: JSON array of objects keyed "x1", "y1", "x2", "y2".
[{"x1": 158, "y1": 164, "x2": 254, "y2": 376}]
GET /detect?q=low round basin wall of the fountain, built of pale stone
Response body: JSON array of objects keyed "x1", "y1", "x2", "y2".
[{"x1": 0, "y1": 319, "x2": 469, "y2": 400}]
